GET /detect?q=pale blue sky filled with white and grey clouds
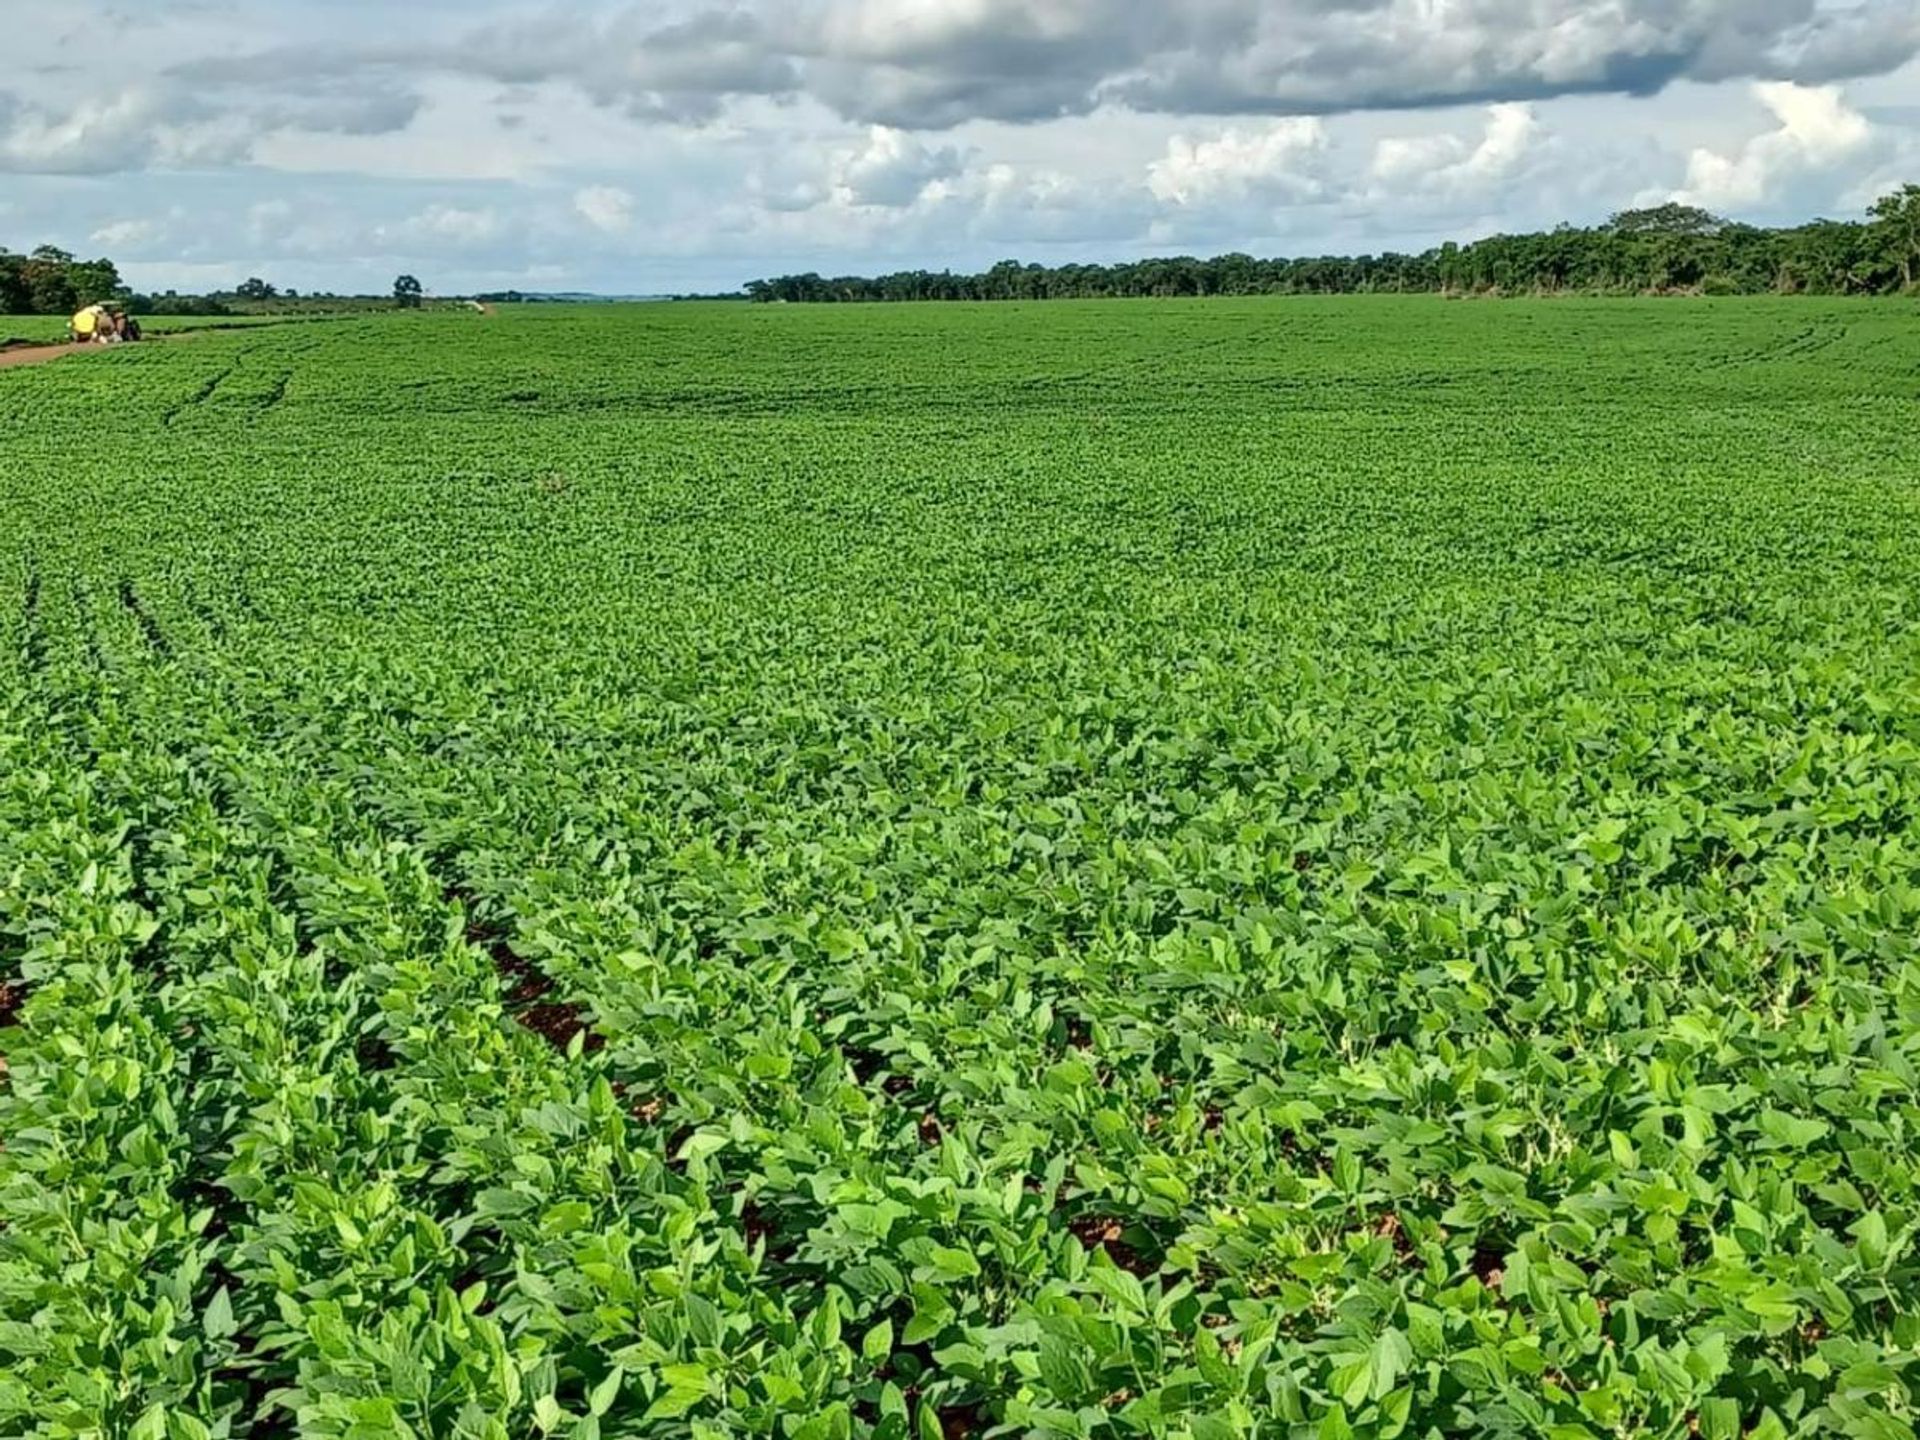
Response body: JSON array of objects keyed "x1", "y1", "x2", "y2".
[{"x1": 0, "y1": 0, "x2": 1920, "y2": 292}]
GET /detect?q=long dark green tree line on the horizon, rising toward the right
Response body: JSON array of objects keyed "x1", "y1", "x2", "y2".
[{"x1": 745, "y1": 184, "x2": 1920, "y2": 303}]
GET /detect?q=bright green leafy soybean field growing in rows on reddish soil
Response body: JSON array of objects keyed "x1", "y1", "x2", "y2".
[{"x1": 0, "y1": 298, "x2": 1920, "y2": 1440}]
